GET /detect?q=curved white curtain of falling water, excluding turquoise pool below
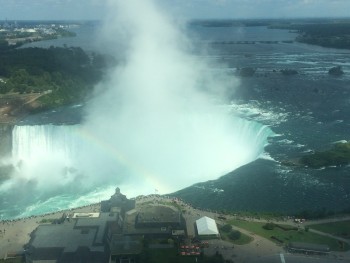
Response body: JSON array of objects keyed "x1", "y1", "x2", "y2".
[{"x1": 12, "y1": 113, "x2": 273, "y2": 194}]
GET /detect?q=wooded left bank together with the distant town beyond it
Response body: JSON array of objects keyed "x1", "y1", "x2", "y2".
[{"x1": 0, "y1": 20, "x2": 116, "y2": 124}]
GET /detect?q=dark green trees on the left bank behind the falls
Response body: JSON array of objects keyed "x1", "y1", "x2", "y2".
[{"x1": 0, "y1": 47, "x2": 116, "y2": 108}]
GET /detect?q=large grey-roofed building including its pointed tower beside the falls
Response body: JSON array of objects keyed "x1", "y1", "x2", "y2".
[{"x1": 26, "y1": 188, "x2": 135, "y2": 263}]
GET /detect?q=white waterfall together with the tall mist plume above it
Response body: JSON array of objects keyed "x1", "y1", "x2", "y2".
[{"x1": 0, "y1": 0, "x2": 272, "y2": 219}]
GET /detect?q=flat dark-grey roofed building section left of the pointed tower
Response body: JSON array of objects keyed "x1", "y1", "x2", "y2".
[{"x1": 26, "y1": 213, "x2": 122, "y2": 263}]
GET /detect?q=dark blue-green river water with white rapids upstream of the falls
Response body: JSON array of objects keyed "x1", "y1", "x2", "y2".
[{"x1": 6, "y1": 22, "x2": 350, "y2": 216}]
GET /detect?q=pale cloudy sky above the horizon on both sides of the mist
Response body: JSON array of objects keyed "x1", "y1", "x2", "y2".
[{"x1": 0, "y1": 0, "x2": 350, "y2": 20}]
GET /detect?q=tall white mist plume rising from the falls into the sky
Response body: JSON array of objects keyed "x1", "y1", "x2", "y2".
[{"x1": 80, "y1": 1, "x2": 256, "y2": 196}]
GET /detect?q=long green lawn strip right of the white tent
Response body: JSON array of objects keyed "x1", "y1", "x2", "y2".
[{"x1": 230, "y1": 220, "x2": 350, "y2": 251}]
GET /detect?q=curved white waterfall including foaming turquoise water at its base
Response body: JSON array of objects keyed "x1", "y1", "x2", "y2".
[{"x1": 0, "y1": 116, "x2": 274, "y2": 220}]
